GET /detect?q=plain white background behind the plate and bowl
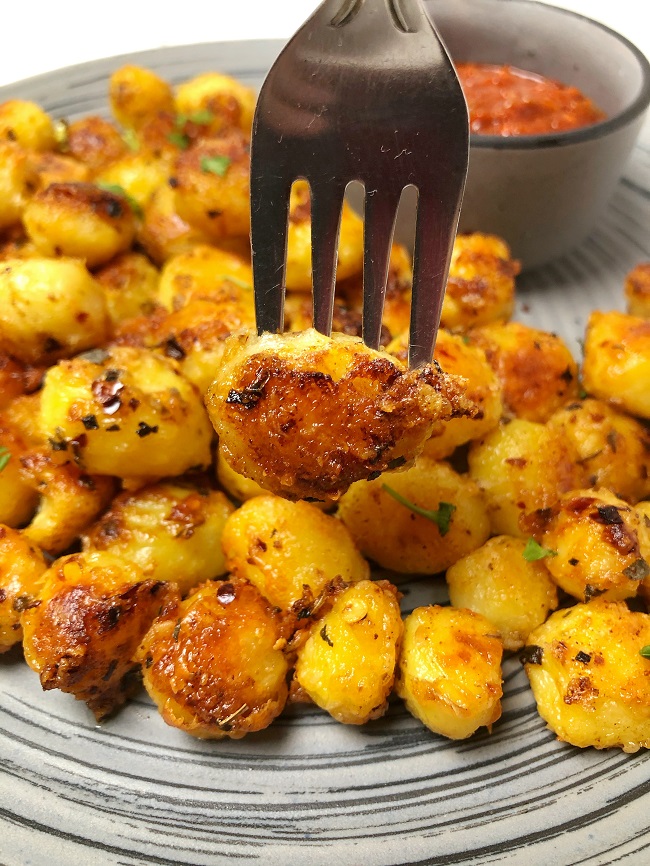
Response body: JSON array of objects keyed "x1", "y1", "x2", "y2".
[{"x1": 0, "y1": 0, "x2": 650, "y2": 85}]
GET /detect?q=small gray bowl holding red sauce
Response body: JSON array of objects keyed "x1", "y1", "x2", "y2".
[{"x1": 397, "y1": 0, "x2": 650, "y2": 269}]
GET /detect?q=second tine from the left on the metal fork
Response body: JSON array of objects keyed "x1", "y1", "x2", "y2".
[{"x1": 311, "y1": 181, "x2": 343, "y2": 336}]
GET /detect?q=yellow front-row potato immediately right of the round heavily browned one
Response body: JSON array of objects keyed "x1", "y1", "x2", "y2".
[{"x1": 294, "y1": 580, "x2": 403, "y2": 725}]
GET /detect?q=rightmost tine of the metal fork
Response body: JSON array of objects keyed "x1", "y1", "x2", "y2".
[{"x1": 409, "y1": 189, "x2": 459, "y2": 369}]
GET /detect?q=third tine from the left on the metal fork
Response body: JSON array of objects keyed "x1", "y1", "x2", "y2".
[{"x1": 363, "y1": 190, "x2": 401, "y2": 349}]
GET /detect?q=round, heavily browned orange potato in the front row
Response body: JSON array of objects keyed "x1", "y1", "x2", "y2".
[{"x1": 137, "y1": 579, "x2": 289, "y2": 739}]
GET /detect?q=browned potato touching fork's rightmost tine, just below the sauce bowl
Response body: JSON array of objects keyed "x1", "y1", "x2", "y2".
[{"x1": 441, "y1": 232, "x2": 520, "y2": 331}]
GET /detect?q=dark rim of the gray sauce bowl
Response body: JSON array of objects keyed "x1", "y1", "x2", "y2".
[{"x1": 440, "y1": 0, "x2": 650, "y2": 150}]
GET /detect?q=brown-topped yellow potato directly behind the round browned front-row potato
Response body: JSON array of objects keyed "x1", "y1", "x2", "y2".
[{"x1": 83, "y1": 482, "x2": 234, "y2": 595}]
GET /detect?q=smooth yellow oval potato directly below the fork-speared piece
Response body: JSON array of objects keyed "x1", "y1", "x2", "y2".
[{"x1": 222, "y1": 495, "x2": 370, "y2": 610}]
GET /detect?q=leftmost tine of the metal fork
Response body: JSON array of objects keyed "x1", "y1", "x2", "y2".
[{"x1": 250, "y1": 171, "x2": 291, "y2": 334}]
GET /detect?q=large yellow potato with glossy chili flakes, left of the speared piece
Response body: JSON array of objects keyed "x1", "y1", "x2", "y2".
[{"x1": 40, "y1": 346, "x2": 212, "y2": 479}]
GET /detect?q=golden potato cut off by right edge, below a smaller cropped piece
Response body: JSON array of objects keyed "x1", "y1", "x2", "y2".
[{"x1": 582, "y1": 310, "x2": 650, "y2": 419}]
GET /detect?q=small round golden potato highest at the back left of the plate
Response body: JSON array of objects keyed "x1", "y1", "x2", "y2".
[{"x1": 108, "y1": 64, "x2": 174, "y2": 129}]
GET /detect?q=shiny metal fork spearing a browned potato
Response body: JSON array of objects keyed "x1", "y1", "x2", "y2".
[{"x1": 251, "y1": 0, "x2": 469, "y2": 368}]
